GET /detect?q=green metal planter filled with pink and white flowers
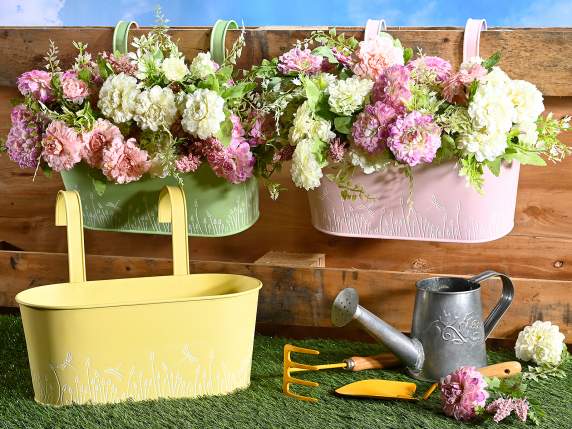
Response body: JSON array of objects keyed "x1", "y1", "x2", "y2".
[{"x1": 1, "y1": 12, "x2": 272, "y2": 236}]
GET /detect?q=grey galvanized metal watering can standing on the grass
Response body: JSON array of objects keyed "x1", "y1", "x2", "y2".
[{"x1": 331, "y1": 271, "x2": 514, "y2": 381}]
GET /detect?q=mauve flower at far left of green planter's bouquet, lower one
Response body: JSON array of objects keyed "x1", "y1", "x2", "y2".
[{"x1": 6, "y1": 104, "x2": 46, "y2": 168}]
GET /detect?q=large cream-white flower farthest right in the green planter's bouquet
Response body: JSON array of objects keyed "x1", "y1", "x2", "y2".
[{"x1": 181, "y1": 89, "x2": 225, "y2": 140}]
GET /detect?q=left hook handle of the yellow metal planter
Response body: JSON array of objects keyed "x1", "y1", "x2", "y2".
[{"x1": 56, "y1": 191, "x2": 85, "y2": 283}]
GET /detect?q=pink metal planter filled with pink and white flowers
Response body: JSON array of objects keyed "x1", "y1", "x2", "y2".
[{"x1": 249, "y1": 29, "x2": 570, "y2": 241}]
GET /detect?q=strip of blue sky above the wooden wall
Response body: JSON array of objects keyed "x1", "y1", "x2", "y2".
[{"x1": 0, "y1": 0, "x2": 572, "y2": 27}]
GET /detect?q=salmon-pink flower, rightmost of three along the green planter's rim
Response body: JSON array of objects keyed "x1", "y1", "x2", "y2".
[{"x1": 101, "y1": 138, "x2": 151, "y2": 183}]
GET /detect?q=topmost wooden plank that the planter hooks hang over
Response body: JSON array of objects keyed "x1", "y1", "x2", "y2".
[{"x1": 0, "y1": 27, "x2": 572, "y2": 96}]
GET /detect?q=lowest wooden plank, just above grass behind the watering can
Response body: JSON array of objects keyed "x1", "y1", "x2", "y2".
[{"x1": 0, "y1": 247, "x2": 572, "y2": 342}]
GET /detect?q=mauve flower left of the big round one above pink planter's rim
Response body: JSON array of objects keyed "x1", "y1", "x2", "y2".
[{"x1": 352, "y1": 101, "x2": 397, "y2": 153}]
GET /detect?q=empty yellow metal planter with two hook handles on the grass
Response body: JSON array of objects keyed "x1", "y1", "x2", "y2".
[{"x1": 16, "y1": 187, "x2": 262, "y2": 405}]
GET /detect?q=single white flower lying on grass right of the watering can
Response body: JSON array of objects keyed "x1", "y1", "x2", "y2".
[{"x1": 514, "y1": 320, "x2": 564, "y2": 365}]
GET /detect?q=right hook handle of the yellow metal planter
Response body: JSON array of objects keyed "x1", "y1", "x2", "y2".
[{"x1": 159, "y1": 186, "x2": 190, "y2": 276}]
